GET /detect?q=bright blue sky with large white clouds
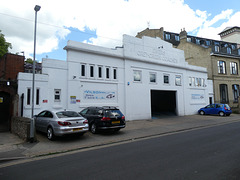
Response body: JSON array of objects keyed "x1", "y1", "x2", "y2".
[{"x1": 0, "y1": 0, "x2": 240, "y2": 62}]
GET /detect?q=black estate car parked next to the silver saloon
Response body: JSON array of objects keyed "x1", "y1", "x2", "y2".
[{"x1": 80, "y1": 106, "x2": 126, "y2": 134}]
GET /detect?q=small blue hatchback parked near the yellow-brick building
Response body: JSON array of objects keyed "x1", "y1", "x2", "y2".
[{"x1": 198, "y1": 104, "x2": 232, "y2": 116}]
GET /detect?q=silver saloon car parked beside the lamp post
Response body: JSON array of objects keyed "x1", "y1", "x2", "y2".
[{"x1": 35, "y1": 110, "x2": 88, "y2": 140}]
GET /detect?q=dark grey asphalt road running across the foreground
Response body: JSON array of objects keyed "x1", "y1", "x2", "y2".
[{"x1": 0, "y1": 122, "x2": 240, "y2": 180}]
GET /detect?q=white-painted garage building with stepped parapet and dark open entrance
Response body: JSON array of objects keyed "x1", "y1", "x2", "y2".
[{"x1": 18, "y1": 35, "x2": 213, "y2": 120}]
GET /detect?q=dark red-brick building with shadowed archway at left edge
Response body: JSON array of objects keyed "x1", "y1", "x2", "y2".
[{"x1": 0, "y1": 53, "x2": 25, "y2": 132}]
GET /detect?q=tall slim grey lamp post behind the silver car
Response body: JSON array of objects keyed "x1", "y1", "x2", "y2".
[{"x1": 32, "y1": 5, "x2": 41, "y2": 118}]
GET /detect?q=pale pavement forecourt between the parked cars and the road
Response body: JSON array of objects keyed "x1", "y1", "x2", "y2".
[{"x1": 0, "y1": 114, "x2": 240, "y2": 167}]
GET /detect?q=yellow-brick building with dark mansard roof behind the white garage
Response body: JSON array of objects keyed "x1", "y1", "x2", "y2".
[{"x1": 136, "y1": 26, "x2": 240, "y2": 107}]
